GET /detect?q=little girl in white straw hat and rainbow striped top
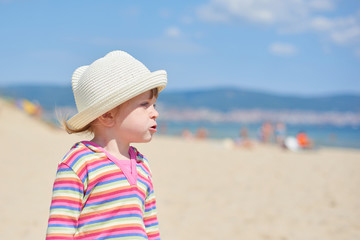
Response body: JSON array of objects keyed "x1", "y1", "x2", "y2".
[{"x1": 46, "y1": 51, "x2": 167, "y2": 240}]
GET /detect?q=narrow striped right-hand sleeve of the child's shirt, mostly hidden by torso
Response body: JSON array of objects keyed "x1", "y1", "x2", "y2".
[{"x1": 144, "y1": 178, "x2": 160, "y2": 240}]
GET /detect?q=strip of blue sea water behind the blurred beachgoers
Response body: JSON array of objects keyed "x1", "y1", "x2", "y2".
[{"x1": 159, "y1": 121, "x2": 360, "y2": 149}]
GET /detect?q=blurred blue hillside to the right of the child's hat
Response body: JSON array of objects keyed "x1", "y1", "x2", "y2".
[{"x1": 159, "y1": 88, "x2": 360, "y2": 112}]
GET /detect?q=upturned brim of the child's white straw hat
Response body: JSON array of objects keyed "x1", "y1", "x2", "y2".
[{"x1": 67, "y1": 70, "x2": 167, "y2": 131}]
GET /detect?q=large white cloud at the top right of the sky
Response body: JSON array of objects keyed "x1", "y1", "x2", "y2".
[{"x1": 197, "y1": 0, "x2": 360, "y2": 51}]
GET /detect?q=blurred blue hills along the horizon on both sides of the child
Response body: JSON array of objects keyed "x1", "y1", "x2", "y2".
[{"x1": 0, "y1": 86, "x2": 360, "y2": 112}]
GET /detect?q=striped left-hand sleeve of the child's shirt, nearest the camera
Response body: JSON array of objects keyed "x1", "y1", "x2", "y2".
[{"x1": 46, "y1": 163, "x2": 84, "y2": 240}]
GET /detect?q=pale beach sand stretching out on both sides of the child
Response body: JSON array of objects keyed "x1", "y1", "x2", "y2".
[{"x1": 0, "y1": 98, "x2": 360, "y2": 240}]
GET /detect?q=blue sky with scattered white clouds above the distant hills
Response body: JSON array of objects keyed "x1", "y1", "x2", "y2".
[{"x1": 0, "y1": 0, "x2": 360, "y2": 95}]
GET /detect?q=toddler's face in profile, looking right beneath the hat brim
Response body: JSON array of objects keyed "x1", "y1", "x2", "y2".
[{"x1": 115, "y1": 91, "x2": 159, "y2": 143}]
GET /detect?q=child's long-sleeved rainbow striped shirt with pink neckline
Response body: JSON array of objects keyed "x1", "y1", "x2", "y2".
[{"x1": 46, "y1": 142, "x2": 160, "y2": 240}]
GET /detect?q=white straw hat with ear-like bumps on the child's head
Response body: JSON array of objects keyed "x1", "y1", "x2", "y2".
[{"x1": 67, "y1": 51, "x2": 167, "y2": 130}]
